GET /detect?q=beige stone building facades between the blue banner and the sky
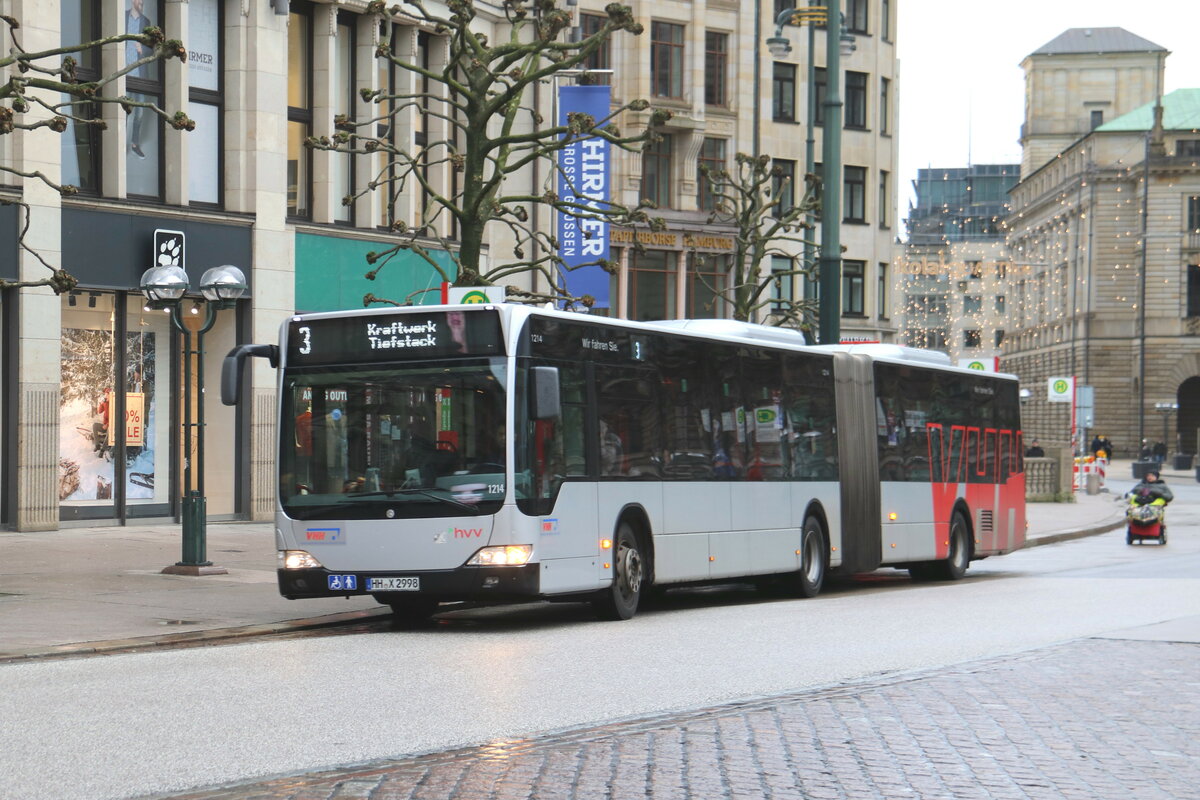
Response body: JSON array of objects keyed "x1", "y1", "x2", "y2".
[{"x1": 578, "y1": 0, "x2": 900, "y2": 342}]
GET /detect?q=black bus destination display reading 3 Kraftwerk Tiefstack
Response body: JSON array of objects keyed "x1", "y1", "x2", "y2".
[{"x1": 287, "y1": 311, "x2": 503, "y2": 366}]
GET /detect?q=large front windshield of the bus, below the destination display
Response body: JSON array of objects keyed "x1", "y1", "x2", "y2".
[{"x1": 280, "y1": 357, "x2": 505, "y2": 519}]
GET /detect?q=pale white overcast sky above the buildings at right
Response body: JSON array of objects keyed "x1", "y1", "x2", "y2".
[{"x1": 895, "y1": 0, "x2": 1200, "y2": 217}]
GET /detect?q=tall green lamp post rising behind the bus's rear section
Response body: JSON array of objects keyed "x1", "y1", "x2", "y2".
[{"x1": 755, "y1": 0, "x2": 856, "y2": 344}]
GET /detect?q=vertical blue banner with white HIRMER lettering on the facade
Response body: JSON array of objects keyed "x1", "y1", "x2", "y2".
[{"x1": 558, "y1": 86, "x2": 612, "y2": 308}]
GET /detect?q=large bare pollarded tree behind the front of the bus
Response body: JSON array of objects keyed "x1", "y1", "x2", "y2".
[{"x1": 308, "y1": 0, "x2": 671, "y2": 305}]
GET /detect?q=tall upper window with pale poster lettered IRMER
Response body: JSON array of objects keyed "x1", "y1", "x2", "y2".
[{"x1": 186, "y1": 0, "x2": 222, "y2": 206}]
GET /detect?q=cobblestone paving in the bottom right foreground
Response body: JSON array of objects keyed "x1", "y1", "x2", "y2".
[{"x1": 154, "y1": 639, "x2": 1200, "y2": 800}]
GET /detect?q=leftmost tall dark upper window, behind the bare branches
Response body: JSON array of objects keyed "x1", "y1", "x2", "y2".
[{"x1": 59, "y1": 0, "x2": 101, "y2": 194}]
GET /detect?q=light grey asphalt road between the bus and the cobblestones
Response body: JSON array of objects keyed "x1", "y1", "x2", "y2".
[{"x1": 0, "y1": 486, "x2": 1200, "y2": 800}]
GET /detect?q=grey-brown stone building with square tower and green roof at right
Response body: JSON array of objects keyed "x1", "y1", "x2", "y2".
[{"x1": 1002, "y1": 31, "x2": 1200, "y2": 457}]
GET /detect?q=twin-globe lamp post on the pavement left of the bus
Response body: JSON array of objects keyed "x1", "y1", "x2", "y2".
[{"x1": 142, "y1": 265, "x2": 247, "y2": 576}]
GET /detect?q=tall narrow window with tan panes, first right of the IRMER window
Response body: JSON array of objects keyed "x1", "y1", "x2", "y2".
[{"x1": 287, "y1": 4, "x2": 312, "y2": 217}]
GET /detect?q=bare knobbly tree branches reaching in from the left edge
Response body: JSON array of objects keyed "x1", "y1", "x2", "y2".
[{"x1": 0, "y1": 14, "x2": 189, "y2": 294}]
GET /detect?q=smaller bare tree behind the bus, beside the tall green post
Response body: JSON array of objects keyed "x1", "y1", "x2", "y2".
[{"x1": 696, "y1": 152, "x2": 821, "y2": 341}]
